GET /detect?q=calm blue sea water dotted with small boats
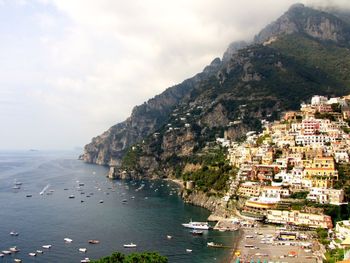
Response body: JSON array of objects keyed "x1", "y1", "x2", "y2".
[{"x1": 0, "y1": 152, "x2": 236, "y2": 263}]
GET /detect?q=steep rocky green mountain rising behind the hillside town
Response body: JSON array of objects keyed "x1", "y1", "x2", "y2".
[{"x1": 81, "y1": 4, "x2": 350, "y2": 179}]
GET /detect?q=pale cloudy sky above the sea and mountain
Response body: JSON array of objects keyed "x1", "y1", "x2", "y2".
[{"x1": 0, "y1": 0, "x2": 350, "y2": 150}]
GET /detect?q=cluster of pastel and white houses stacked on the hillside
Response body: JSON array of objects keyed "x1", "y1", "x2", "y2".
[{"x1": 218, "y1": 96, "x2": 350, "y2": 228}]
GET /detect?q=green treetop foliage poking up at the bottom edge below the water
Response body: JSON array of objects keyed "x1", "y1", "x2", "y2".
[{"x1": 91, "y1": 252, "x2": 168, "y2": 263}]
